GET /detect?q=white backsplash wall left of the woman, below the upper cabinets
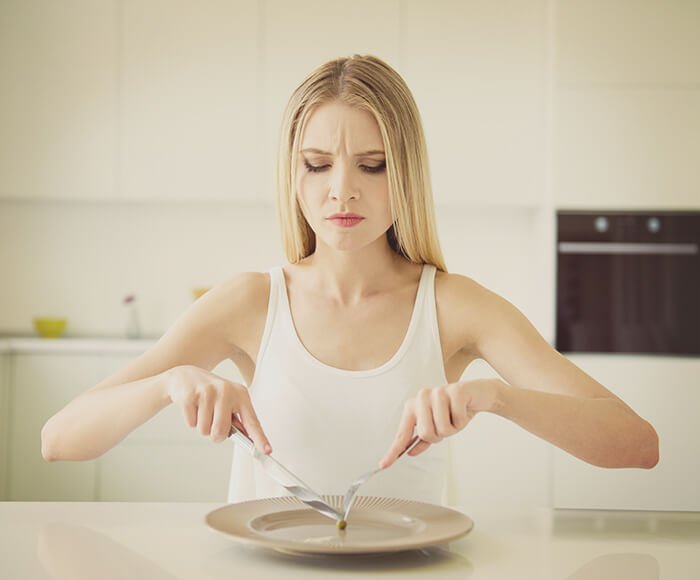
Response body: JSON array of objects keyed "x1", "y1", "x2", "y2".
[{"x1": 0, "y1": 202, "x2": 281, "y2": 337}]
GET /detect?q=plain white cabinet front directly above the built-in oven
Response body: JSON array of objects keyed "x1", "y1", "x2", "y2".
[{"x1": 553, "y1": 0, "x2": 700, "y2": 209}]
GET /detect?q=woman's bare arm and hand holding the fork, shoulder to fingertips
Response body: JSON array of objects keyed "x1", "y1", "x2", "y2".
[{"x1": 382, "y1": 275, "x2": 659, "y2": 468}]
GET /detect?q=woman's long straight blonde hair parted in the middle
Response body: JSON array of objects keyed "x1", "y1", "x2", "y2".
[{"x1": 277, "y1": 55, "x2": 447, "y2": 271}]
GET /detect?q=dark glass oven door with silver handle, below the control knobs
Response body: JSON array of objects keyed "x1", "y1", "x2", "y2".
[{"x1": 556, "y1": 241, "x2": 700, "y2": 356}]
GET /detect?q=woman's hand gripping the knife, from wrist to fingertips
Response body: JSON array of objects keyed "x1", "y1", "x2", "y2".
[{"x1": 163, "y1": 365, "x2": 272, "y2": 454}]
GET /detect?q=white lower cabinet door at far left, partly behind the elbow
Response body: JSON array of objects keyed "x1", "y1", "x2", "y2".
[{"x1": 8, "y1": 353, "x2": 100, "y2": 501}]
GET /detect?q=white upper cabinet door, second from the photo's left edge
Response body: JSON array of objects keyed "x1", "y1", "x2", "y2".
[{"x1": 119, "y1": 0, "x2": 267, "y2": 201}]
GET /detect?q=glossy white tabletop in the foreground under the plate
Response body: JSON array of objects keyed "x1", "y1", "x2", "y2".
[{"x1": 0, "y1": 502, "x2": 700, "y2": 580}]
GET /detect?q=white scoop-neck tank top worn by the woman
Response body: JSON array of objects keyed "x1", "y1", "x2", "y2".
[{"x1": 228, "y1": 265, "x2": 447, "y2": 503}]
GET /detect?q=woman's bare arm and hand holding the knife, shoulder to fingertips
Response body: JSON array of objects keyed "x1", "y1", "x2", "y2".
[{"x1": 41, "y1": 273, "x2": 269, "y2": 461}]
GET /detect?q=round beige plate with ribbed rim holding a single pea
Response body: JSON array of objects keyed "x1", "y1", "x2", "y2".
[{"x1": 205, "y1": 495, "x2": 474, "y2": 554}]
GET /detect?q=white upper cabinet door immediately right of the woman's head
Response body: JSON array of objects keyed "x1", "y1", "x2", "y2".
[{"x1": 400, "y1": 0, "x2": 550, "y2": 207}]
